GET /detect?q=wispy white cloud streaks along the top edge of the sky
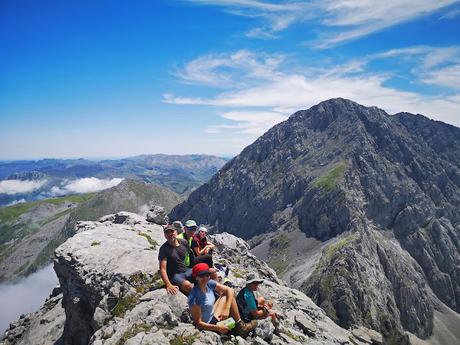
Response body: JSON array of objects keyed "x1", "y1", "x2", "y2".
[{"x1": 189, "y1": 0, "x2": 458, "y2": 48}]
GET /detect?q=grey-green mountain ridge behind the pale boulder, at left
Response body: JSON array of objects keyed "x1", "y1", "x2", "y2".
[{"x1": 0, "y1": 179, "x2": 181, "y2": 282}]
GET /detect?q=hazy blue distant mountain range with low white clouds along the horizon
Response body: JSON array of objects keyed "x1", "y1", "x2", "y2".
[{"x1": 0, "y1": 154, "x2": 226, "y2": 207}]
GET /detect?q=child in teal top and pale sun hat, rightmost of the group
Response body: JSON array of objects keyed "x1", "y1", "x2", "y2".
[{"x1": 236, "y1": 273, "x2": 279, "y2": 327}]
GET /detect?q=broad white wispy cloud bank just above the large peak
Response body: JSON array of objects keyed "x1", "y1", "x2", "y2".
[{"x1": 164, "y1": 47, "x2": 460, "y2": 136}]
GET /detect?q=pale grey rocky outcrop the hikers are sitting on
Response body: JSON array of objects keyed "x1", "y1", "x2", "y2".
[{"x1": 0, "y1": 212, "x2": 382, "y2": 345}]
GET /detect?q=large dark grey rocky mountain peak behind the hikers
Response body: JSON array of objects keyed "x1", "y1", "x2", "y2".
[{"x1": 170, "y1": 99, "x2": 460, "y2": 344}]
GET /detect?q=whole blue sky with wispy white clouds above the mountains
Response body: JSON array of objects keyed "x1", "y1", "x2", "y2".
[{"x1": 0, "y1": 0, "x2": 460, "y2": 159}]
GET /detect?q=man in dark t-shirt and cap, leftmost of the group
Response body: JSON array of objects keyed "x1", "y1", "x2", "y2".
[{"x1": 158, "y1": 226, "x2": 193, "y2": 295}]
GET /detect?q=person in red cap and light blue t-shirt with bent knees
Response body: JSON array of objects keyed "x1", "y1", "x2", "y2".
[{"x1": 188, "y1": 263, "x2": 257, "y2": 337}]
